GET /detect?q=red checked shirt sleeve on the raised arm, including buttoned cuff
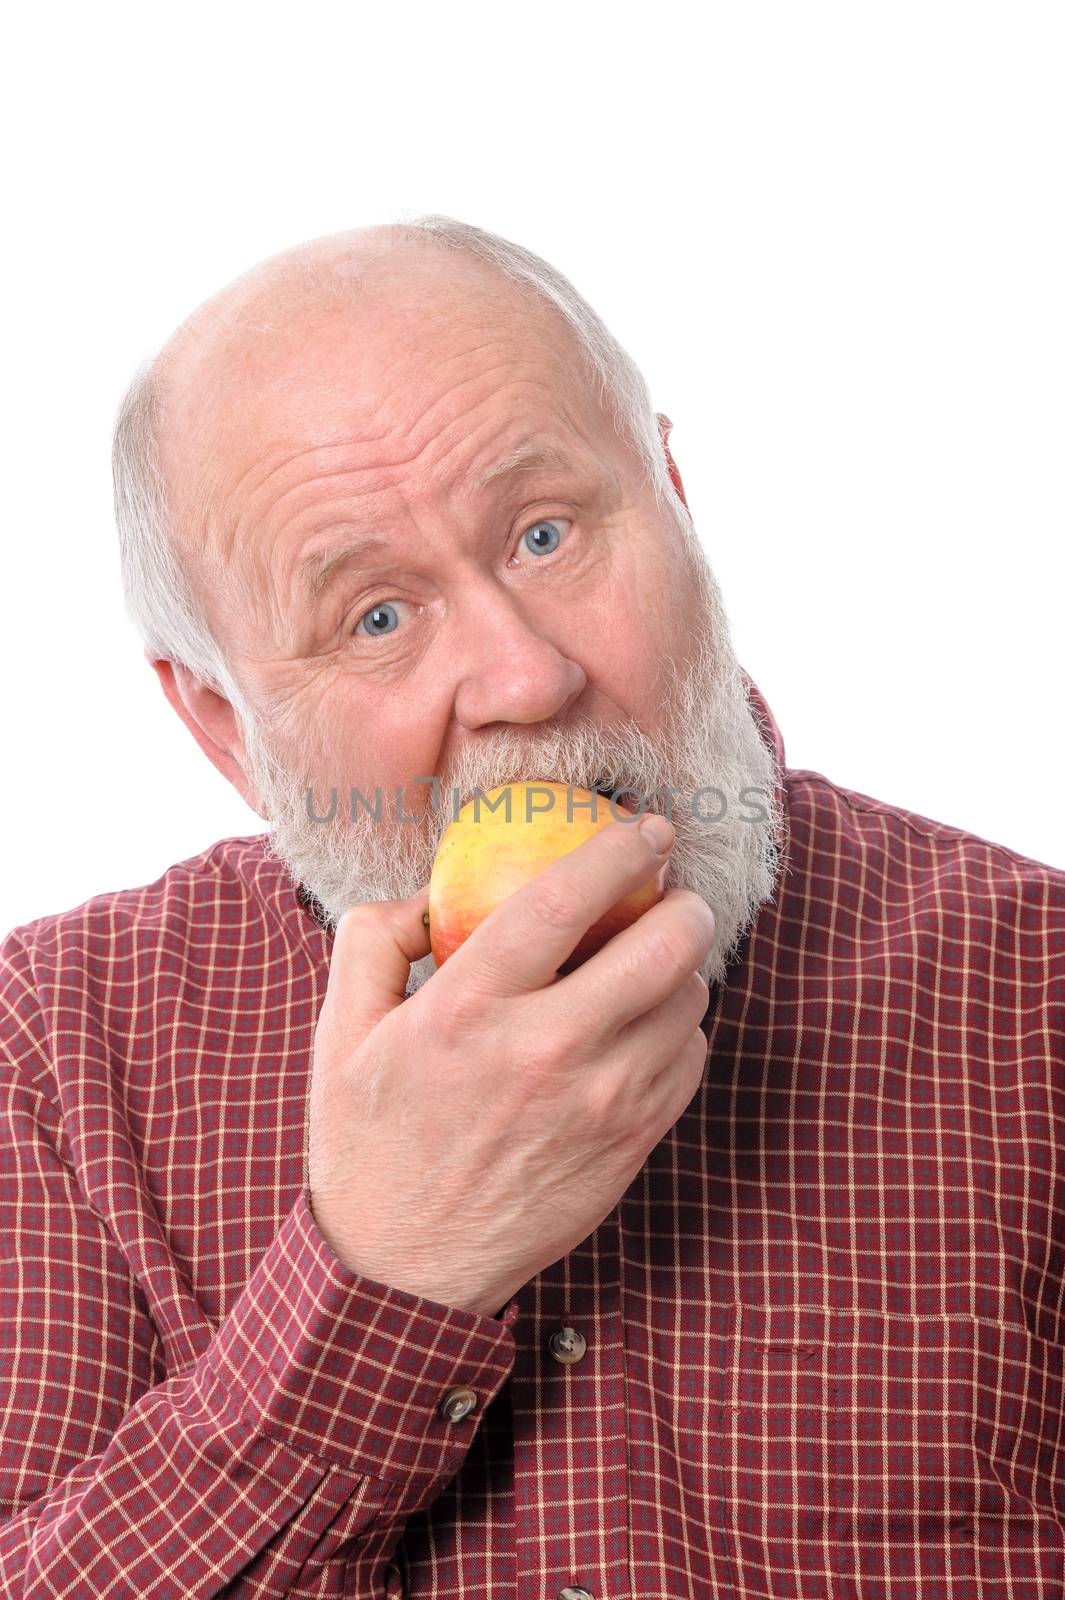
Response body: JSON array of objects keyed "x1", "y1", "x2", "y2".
[{"x1": 0, "y1": 934, "x2": 518, "y2": 1600}]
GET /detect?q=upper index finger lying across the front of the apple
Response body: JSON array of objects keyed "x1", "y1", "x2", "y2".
[{"x1": 440, "y1": 814, "x2": 673, "y2": 995}]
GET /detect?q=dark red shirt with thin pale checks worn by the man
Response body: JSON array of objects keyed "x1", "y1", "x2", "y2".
[{"x1": 0, "y1": 685, "x2": 1065, "y2": 1600}]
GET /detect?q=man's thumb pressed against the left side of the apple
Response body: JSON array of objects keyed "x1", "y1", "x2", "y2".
[{"x1": 323, "y1": 883, "x2": 430, "y2": 1048}]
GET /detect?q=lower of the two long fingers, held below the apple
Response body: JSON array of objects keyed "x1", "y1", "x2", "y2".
[{"x1": 552, "y1": 890, "x2": 716, "y2": 1048}]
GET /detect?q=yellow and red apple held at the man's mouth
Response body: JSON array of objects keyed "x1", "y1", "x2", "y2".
[{"x1": 429, "y1": 782, "x2": 664, "y2": 973}]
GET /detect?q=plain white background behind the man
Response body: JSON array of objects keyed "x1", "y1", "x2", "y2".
[{"x1": 0, "y1": 0, "x2": 1065, "y2": 931}]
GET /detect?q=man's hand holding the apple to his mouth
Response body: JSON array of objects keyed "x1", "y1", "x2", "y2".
[{"x1": 309, "y1": 818, "x2": 713, "y2": 1315}]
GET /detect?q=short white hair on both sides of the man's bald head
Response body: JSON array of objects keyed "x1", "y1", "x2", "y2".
[{"x1": 112, "y1": 213, "x2": 699, "y2": 710}]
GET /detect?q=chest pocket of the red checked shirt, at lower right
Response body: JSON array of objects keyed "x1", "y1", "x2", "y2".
[{"x1": 721, "y1": 1306, "x2": 1065, "y2": 1600}]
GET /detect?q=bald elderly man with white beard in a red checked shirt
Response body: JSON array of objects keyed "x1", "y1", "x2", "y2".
[{"x1": 0, "y1": 216, "x2": 1065, "y2": 1600}]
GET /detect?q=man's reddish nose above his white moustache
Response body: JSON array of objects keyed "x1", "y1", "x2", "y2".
[{"x1": 444, "y1": 582, "x2": 587, "y2": 728}]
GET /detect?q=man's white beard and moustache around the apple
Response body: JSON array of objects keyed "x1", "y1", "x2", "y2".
[{"x1": 240, "y1": 539, "x2": 784, "y2": 994}]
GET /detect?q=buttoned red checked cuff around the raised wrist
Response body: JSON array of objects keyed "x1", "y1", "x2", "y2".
[{"x1": 197, "y1": 1186, "x2": 520, "y2": 1486}]
